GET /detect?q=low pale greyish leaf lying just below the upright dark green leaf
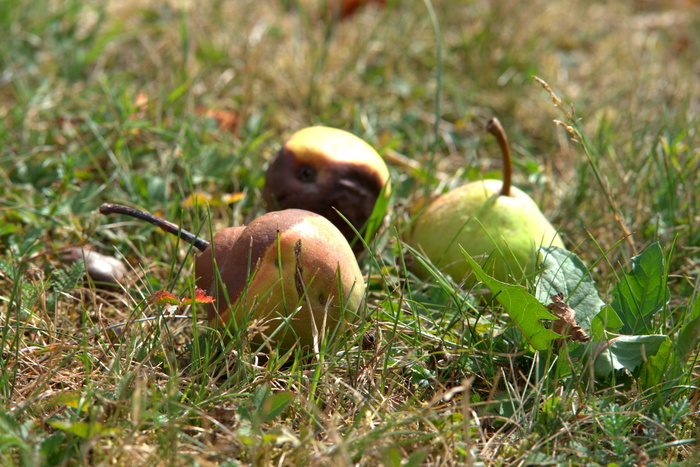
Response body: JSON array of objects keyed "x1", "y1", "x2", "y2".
[{"x1": 592, "y1": 334, "x2": 667, "y2": 376}]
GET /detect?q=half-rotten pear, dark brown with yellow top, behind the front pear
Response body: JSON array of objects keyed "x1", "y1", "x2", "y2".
[{"x1": 263, "y1": 126, "x2": 389, "y2": 252}]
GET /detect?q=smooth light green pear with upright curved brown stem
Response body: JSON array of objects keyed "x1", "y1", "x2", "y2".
[{"x1": 407, "y1": 118, "x2": 564, "y2": 286}]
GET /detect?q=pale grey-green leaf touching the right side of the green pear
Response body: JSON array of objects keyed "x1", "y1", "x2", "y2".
[{"x1": 535, "y1": 246, "x2": 605, "y2": 332}]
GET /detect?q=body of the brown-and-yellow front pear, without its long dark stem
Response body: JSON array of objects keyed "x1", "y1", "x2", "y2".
[{"x1": 195, "y1": 209, "x2": 365, "y2": 349}]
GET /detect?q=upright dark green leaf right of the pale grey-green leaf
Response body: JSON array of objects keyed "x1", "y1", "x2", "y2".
[{"x1": 611, "y1": 242, "x2": 670, "y2": 334}]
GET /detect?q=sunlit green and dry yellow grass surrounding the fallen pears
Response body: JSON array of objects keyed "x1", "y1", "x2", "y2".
[{"x1": 0, "y1": 0, "x2": 700, "y2": 465}]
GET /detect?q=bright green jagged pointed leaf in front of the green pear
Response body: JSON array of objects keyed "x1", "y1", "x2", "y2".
[{"x1": 462, "y1": 249, "x2": 561, "y2": 350}]
